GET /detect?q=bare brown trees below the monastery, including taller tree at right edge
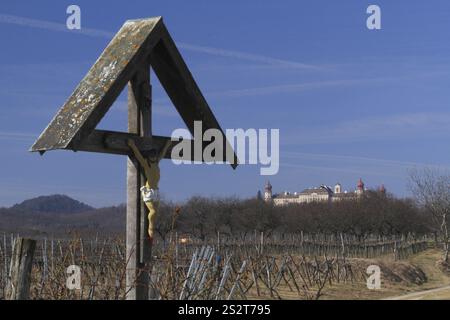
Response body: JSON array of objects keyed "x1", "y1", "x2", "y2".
[{"x1": 156, "y1": 169, "x2": 450, "y2": 263}]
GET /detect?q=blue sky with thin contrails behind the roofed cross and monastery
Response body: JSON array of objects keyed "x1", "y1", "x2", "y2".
[{"x1": 0, "y1": 0, "x2": 450, "y2": 206}]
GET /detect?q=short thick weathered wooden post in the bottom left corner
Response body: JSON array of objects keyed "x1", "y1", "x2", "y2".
[{"x1": 6, "y1": 238, "x2": 36, "y2": 300}]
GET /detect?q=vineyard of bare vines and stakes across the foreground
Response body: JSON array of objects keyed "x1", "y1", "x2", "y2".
[{"x1": 0, "y1": 233, "x2": 430, "y2": 300}]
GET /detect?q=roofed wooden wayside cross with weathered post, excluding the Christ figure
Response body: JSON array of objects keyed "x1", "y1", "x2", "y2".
[{"x1": 31, "y1": 17, "x2": 237, "y2": 300}]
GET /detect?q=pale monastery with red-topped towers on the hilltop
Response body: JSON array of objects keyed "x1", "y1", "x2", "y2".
[{"x1": 264, "y1": 178, "x2": 386, "y2": 206}]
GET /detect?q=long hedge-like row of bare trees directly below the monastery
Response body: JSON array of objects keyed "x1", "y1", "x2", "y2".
[{"x1": 156, "y1": 192, "x2": 426, "y2": 240}]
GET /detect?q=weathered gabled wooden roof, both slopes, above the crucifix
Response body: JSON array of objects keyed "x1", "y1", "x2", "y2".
[{"x1": 30, "y1": 17, "x2": 237, "y2": 167}]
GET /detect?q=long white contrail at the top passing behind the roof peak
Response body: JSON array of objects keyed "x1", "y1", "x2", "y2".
[{"x1": 0, "y1": 13, "x2": 322, "y2": 70}]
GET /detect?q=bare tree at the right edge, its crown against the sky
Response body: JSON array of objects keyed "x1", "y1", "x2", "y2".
[{"x1": 410, "y1": 169, "x2": 450, "y2": 263}]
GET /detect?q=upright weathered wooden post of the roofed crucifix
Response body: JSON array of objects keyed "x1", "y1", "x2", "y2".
[{"x1": 126, "y1": 63, "x2": 151, "y2": 300}]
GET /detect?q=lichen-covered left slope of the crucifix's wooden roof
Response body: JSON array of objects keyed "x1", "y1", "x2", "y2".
[{"x1": 31, "y1": 17, "x2": 161, "y2": 151}]
